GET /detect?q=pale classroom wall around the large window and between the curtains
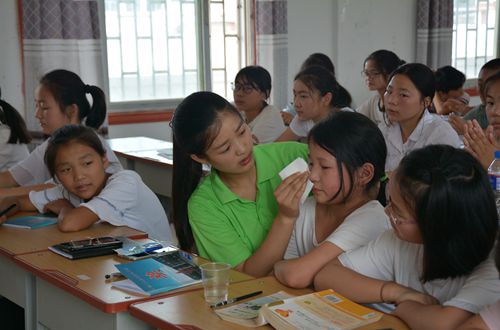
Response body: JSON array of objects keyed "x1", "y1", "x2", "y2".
[{"x1": 0, "y1": 0, "x2": 416, "y2": 140}]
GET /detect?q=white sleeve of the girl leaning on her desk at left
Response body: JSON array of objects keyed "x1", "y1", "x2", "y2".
[{"x1": 80, "y1": 171, "x2": 139, "y2": 226}]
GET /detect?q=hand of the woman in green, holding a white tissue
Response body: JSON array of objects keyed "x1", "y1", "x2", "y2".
[{"x1": 274, "y1": 172, "x2": 309, "y2": 221}]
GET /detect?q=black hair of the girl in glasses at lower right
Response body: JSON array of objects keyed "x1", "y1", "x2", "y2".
[{"x1": 394, "y1": 145, "x2": 498, "y2": 282}]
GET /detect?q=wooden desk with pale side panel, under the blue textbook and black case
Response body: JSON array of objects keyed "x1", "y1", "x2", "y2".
[{"x1": 15, "y1": 251, "x2": 253, "y2": 330}]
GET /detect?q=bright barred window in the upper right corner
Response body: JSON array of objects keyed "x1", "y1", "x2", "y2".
[{"x1": 452, "y1": 0, "x2": 498, "y2": 78}]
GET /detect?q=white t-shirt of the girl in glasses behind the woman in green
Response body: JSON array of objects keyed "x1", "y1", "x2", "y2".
[{"x1": 248, "y1": 105, "x2": 286, "y2": 143}]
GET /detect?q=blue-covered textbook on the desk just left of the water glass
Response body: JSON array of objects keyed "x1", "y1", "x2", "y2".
[{"x1": 112, "y1": 251, "x2": 201, "y2": 296}]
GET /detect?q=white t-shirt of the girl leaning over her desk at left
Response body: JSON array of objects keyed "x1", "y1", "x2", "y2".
[{"x1": 29, "y1": 170, "x2": 172, "y2": 241}]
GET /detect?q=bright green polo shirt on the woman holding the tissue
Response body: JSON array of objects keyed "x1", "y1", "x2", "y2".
[{"x1": 188, "y1": 142, "x2": 308, "y2": 266}]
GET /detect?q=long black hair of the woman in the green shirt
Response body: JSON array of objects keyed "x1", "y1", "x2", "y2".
[{"x1": 170, "y1": 92, "x2": 243, "y2": 250}]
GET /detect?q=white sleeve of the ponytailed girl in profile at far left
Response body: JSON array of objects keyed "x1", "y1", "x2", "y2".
[{"x1": 9, "y1": 141, "x2": 50, "y2": 186}]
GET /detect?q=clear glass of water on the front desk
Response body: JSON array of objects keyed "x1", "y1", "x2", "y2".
[{"x1": 200, "y1": 262, "x2": 231, "y2": 305}]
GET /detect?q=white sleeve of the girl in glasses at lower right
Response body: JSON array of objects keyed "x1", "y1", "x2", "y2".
[{"x1": 339, "y1": 229, "x2": 397, "y2": 281}]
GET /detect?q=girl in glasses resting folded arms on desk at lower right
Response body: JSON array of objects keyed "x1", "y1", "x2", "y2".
[{"x1": 314, "y1": 145, "x2": 500, "y2": 329}]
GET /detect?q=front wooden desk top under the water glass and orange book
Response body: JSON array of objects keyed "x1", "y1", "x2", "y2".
[{"x1": 130, "y1": 277, "x2": 408, "y2": 330}]
